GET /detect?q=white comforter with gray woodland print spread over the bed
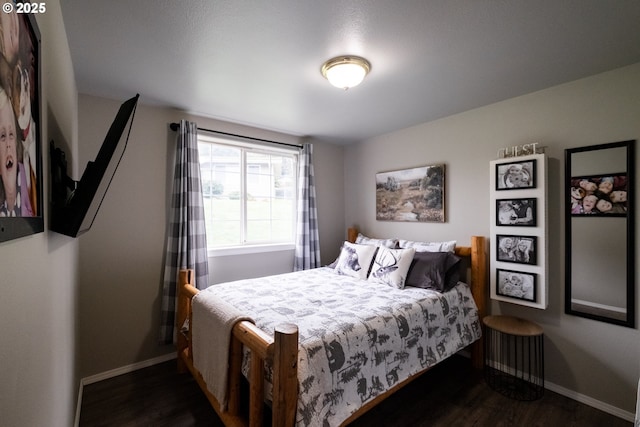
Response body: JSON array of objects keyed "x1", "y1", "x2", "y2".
[{"x1": 196, "y1": 267, "x2": 481, "y2": 426}]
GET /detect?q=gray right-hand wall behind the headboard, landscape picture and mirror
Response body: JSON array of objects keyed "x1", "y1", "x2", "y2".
[{"x1": 345, "y1": 64, "x2": 640, "y2": 413}]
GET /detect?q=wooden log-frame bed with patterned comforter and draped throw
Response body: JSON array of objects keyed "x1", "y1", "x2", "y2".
[{"x1": 177, "y1": 229, "x2": 486, "y2": 426}]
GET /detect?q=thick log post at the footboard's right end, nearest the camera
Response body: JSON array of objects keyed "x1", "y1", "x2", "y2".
[{"x1": 272, "y1": 323, "x2": 298, "y2": 427}]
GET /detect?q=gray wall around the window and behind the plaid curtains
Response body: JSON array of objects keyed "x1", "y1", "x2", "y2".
[{"x1": 78, "y1": 94, "x2": 345, "y2": 377}]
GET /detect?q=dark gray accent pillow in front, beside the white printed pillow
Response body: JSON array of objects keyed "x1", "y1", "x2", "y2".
[{"x1": 405, "y1": 252, "x2": 460, "y2": 292}]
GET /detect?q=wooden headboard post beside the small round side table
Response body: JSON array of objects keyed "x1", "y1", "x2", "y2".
[{"x1": 471, "y1": 236, "x2": 487, "y2": 368}]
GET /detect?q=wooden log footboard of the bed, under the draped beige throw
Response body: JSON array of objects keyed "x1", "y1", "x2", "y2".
[{"x1": 176, "y1": 270, "x2": 298, "y2": 427}]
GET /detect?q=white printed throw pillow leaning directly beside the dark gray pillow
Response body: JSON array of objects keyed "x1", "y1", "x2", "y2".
[{"x1": 367, "y1": 247, "x2": 416, "y2": 289}]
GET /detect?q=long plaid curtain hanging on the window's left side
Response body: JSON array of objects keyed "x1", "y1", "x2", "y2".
[{"x1": 160, "y1": 120, "x2": 209, "y2": 344}]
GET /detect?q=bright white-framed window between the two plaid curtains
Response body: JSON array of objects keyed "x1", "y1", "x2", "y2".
[{"x1": 198, "y1": 135, "x2": 298, "y2": 250}]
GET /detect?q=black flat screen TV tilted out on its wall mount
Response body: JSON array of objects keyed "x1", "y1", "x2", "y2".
[{"x1": 50, "y1": 95, "x2": 139, "y2": 237}]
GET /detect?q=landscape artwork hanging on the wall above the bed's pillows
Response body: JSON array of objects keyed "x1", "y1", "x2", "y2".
[{"x1": 376, "y1": 164, "x2": 445, "y2": 222}]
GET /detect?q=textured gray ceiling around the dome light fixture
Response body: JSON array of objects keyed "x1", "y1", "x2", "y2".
[{"x1": 61, "y1": 0, "x2": 640, "y2": 143}]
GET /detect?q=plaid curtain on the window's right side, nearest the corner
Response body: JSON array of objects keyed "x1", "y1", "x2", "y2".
[{"x1": 293, "y1": 143, "x2": 320, "y2": 271}]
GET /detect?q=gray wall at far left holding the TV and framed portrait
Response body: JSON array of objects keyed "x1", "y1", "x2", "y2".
[{"x1": 0, "y1": 0, "x2": 78, "y2": 427}]
